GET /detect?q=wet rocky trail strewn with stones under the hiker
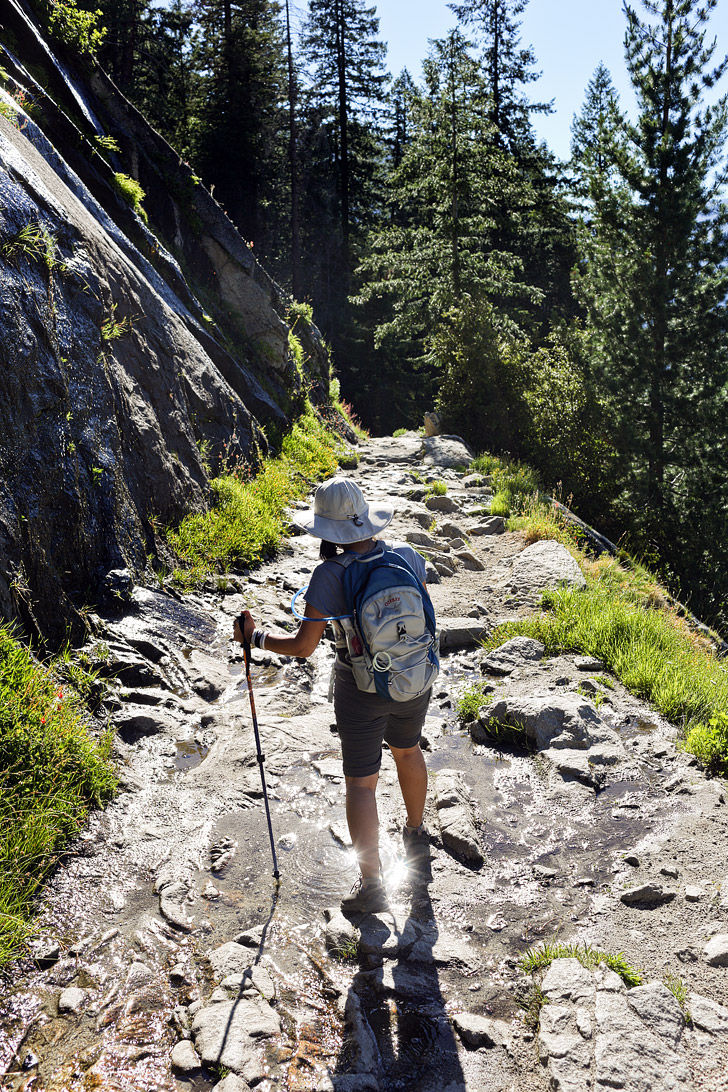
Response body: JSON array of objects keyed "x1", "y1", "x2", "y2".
[{"x1": 0, "y1": 435, "x2": 728, "y2": 1092}]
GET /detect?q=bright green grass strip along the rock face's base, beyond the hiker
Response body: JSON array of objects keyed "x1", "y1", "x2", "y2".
[{"x1": 167, "y1": 408, "x2": 343, "y2": 586}]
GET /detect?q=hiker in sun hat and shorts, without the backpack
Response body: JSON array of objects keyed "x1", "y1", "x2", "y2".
[{"x1": 235, "y1": 476, "x2": 437, "y2": 913}]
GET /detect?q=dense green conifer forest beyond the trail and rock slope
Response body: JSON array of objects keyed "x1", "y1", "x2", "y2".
[{"x1": 79, "y1": 0, "x2": 728, "y2": 628}]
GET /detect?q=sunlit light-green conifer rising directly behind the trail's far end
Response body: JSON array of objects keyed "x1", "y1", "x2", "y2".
[{"x1": 358, "y1": 31, "x2": 540, "y2": 430}]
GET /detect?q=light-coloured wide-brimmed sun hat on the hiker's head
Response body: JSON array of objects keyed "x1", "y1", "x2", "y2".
[{"x1": 293, "y1": 477, "x2": 394, "y2": 545}]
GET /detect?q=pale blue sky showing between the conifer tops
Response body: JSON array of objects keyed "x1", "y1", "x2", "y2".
[{"x1": 370, "y1": 0, "x2": 728, "y2": 157}]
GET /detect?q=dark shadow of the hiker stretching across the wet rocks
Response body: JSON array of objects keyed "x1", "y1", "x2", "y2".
[{"x1": 334, "y1": 847, "x2": 466, "y2": 1092}]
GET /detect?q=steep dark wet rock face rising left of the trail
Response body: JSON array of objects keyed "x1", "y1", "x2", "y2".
[{"x1": 0, "y1": 0, "x2": 329, "y2": 643}]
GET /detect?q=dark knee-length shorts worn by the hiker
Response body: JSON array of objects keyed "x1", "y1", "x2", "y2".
[{"x1": 334, "y1": 667, "x2": 430, "y2": 778}]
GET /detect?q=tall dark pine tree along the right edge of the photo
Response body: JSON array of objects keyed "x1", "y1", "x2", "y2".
[{"x1": 578, "y1": 0, "x2": 728, "y2": 574}]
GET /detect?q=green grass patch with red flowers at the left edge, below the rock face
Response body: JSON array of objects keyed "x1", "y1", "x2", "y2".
[{"x1": 0, "y1": 627, "x2": 116, "y2": 966}]
